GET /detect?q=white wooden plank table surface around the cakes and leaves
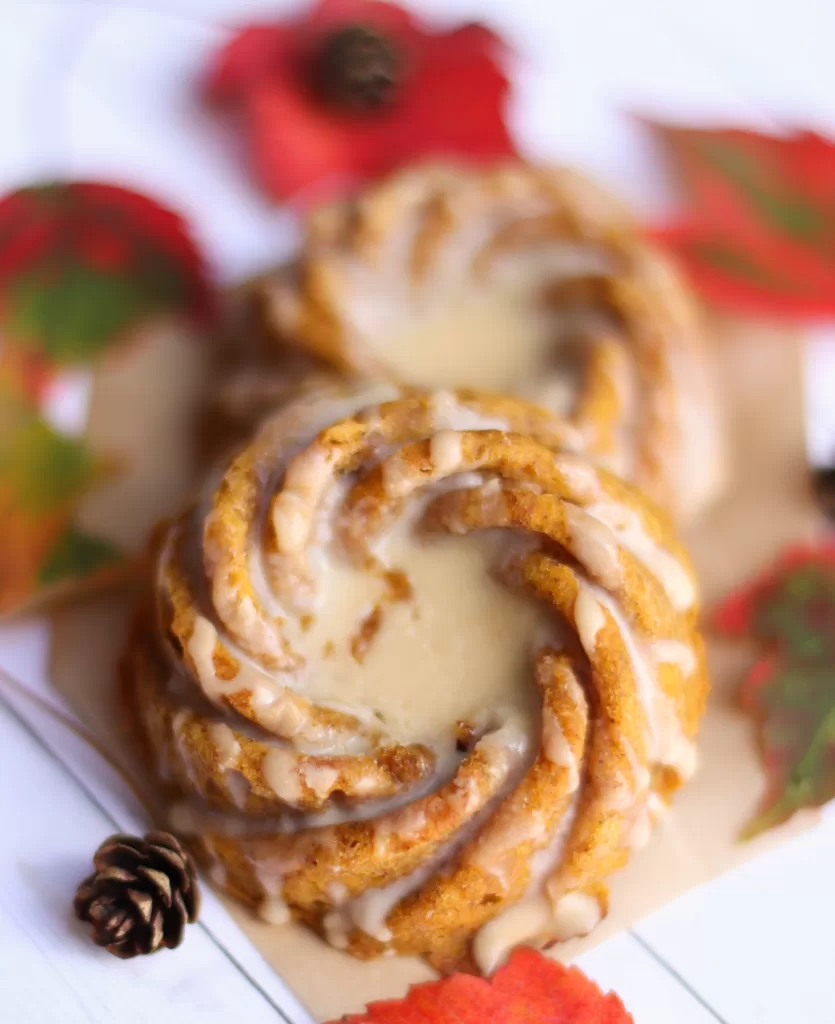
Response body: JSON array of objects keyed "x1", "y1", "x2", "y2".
[{"x1": 0, "y1": 0, "x2": 835, "y2": 1024}]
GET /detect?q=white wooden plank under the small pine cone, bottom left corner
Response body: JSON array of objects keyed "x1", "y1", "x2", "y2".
[{"x1": 0, "y1": 706, "x2": 297, "y2": 1024}]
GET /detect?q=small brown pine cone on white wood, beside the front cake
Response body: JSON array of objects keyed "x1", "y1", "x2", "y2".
[{"x1": 73, "y1": 831, "x2": 200, "y2": 959}]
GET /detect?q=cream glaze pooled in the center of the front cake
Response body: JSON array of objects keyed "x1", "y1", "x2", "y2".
[{"x1": 286, "y1": 517, "x2": 547, "y2": 742}]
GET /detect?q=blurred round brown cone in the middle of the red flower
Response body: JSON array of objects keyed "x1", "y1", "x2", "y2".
[{"x1": 314, "y1": 25, "x2": 403, "y2": 113}]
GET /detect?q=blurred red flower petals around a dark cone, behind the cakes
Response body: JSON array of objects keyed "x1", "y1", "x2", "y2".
[{"x1": 205, "y1": 0, "x2": 515, "y2": 202}]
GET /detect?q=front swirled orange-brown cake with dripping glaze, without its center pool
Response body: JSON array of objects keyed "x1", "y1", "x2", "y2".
[{"x1": 126, "y1": 385, "x2": 708, "y2": 973}]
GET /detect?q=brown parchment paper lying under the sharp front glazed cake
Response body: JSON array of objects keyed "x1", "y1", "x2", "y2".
[{"x1": 52, "y1": 322, "x2": 820, "y2": 1020}]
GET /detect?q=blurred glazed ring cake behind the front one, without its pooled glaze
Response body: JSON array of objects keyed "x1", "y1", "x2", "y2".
[{"x1": 262, "y1": 163, "x2": 724, "y2": 519}]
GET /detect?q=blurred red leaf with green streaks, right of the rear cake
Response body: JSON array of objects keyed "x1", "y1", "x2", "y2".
[{"x1": 654, "y1": 125, "x2": 835, "y2": 318}]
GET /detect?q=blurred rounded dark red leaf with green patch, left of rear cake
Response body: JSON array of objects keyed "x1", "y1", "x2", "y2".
[{"x1": 0, "y1": 182, "x2": 211, "y2": 364}]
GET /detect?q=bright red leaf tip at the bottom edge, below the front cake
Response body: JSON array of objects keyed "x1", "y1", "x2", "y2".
[{"x1": 331, "y1": 948, "x2": 632, "y2": 1024}]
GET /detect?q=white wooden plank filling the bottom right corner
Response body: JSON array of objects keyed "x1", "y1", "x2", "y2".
[{"x1": 635, "y1": 808, "x2": 835, "y2": 1024}]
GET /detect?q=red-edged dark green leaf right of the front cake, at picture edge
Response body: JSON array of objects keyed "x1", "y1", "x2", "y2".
[{"x1": 713, "y1": 543, "x2": 835, "y2": 839}]
